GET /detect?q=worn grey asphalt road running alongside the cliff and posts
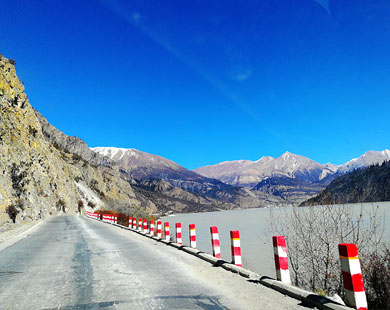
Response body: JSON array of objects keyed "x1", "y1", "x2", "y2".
[{"x1": 0, "y1": 216, "x2": 304, "y2": 310}]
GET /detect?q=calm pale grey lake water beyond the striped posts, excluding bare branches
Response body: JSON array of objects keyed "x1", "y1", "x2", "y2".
[{"x1": 161, "y1": 202, "x2": 390, "y2": 277}]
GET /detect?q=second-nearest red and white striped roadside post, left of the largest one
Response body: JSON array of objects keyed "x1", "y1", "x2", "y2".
[{"x1": 272, "y1": 236, "x2": 291, "y2": 284}]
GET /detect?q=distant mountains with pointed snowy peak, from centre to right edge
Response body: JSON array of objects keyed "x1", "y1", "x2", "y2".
[{"x1": 194, "y1": 150, "x2": 390, "y2": 204}]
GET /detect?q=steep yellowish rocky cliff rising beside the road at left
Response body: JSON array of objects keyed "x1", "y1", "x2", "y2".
[{"x1": 0, "y1": 55, "x2": 157, "y2": 230}]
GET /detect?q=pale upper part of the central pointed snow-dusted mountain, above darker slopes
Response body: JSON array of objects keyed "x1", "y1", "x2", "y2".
[{"x1": 194, "y1": 152, "x2": 337, "y2": 187}]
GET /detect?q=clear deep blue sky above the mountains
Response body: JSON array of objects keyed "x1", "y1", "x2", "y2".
[{"x1": 0, "y1": 0, "x2": 390, "y2": 169}]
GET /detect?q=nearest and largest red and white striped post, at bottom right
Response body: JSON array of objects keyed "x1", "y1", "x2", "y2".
[{"x1": 339, "y1": 243, "x2": 367, "y2": 310}]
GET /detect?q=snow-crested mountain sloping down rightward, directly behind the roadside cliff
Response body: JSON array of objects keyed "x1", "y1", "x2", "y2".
[{"x1": 92, "y1": 147, "x2": 285, "y2": 211}]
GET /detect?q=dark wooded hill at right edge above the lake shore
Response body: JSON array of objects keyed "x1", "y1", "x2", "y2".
[{"x1": 301, "y1": 161, "x2": 390, "y2": 206}]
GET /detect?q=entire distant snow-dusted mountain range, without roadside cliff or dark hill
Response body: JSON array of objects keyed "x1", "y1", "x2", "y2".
[{"x1": 92, "y1": 147, "x2": 390, "y2": 207}]
